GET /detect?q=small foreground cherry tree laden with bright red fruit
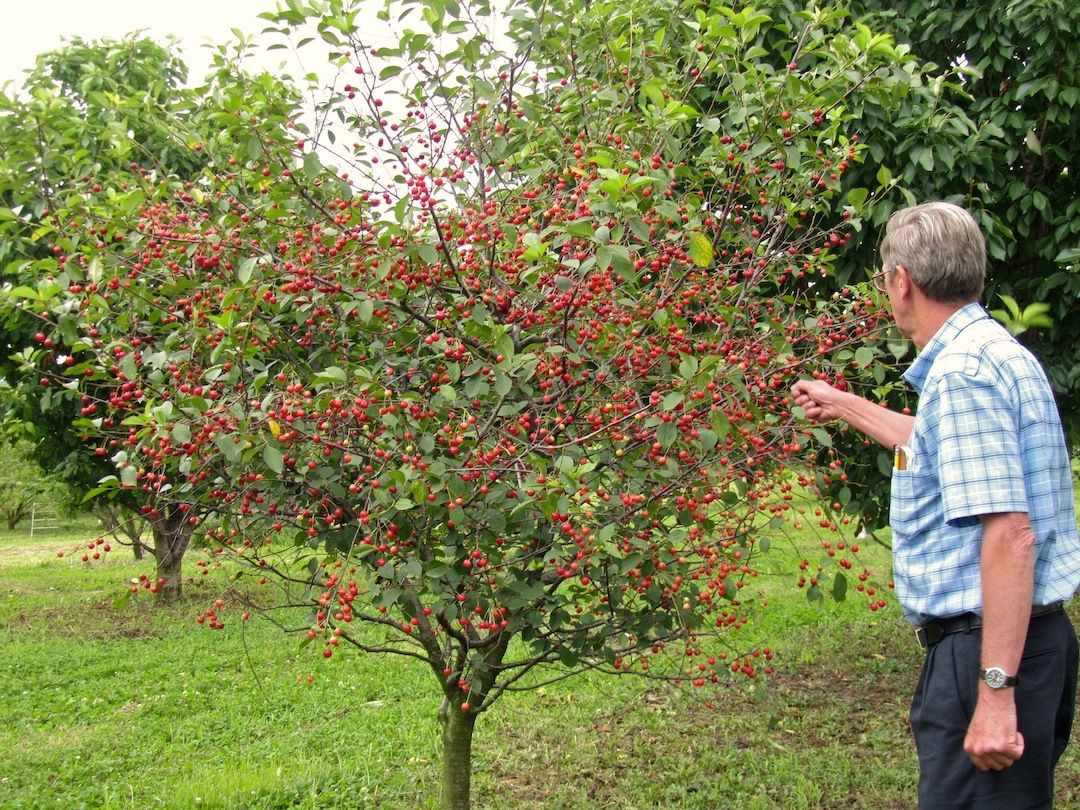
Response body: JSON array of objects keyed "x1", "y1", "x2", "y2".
[{"x1": 8, "y1": 0, "x2": 924, "y2": 808}]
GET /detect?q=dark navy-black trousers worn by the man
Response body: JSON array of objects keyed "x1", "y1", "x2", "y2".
[{"x1": 912, "y1": 612, "x2": 1078, "y2": 810}]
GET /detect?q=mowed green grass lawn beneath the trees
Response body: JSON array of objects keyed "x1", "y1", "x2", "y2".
[{"x1": 0, "y1": 523, "x2": 1080, "y2": 810}]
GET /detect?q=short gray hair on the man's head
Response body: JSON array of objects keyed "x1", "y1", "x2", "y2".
[{"x1": 881, "y1": 202, "x2": 986, "y2": 303}]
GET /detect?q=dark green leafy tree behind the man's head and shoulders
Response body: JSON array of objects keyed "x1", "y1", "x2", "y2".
[{"x1": 837, "y1": 0, "x2": 1080, "y2": 427}]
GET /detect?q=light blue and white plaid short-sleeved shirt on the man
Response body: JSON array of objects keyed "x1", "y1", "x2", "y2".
[{"x1": 890, "y1": 303, "x2": 1080, "y2": 623}]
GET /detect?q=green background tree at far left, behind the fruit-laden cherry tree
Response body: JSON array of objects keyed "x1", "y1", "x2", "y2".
[{"x1": 0, "y1": 36, "x2": 308, "y2": 600}]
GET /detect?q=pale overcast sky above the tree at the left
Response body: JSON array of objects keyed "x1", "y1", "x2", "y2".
[{"x1": 0, "y1": 0, "x2": 308, "y2": 84}]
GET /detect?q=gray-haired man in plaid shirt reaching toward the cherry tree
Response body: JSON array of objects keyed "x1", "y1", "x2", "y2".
[{"x1": 792, "y1": 202, "x2": 1080, "y2": 810}]
